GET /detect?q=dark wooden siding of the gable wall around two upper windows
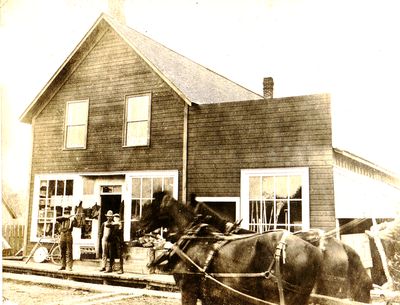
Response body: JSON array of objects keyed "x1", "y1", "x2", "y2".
[{"x1": 32, "y1": 31, "x2": 184, "y2": 175}]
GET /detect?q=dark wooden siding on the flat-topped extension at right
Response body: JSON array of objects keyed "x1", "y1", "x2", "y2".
[{"x1": 188, "y1": 95, "x2": 335, "y2": 228}]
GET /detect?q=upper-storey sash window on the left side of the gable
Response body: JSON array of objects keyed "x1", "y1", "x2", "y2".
[{"x1": 64, "y1": 100, "x2": 89, "y2": 149}]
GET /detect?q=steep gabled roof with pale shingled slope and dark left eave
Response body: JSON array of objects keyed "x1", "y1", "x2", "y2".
[{"x1": 20, "y1": 13, "x2": 263, "y2": 123}]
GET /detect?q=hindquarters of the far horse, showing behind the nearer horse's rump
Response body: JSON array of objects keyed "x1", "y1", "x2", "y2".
[{"x1": 295, "y1": 230, "x2": 372, "y2": 303}]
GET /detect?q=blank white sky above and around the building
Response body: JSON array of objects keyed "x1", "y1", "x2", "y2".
[{"x1": 0, "y1": 0, "x2": 400, "y2": 194}]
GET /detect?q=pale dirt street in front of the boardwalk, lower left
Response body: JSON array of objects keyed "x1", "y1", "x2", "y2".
[{"x1": 2, "y1": 279, "x2": 181, "y2": 305}]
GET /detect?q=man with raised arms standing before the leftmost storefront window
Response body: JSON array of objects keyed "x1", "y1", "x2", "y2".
[{"x1": 56, "y1": 210, "x2": 77, "y2": 271}]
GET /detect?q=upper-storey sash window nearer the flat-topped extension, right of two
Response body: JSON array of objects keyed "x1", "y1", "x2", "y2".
[{"x1": 124, "y1": 94, "x2": 151, "y2": 146}]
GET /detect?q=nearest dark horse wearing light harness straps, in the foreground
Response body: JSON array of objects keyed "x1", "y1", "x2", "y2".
[{"x1": 140, "y1": 192, "x2": 322, "y2": 305}]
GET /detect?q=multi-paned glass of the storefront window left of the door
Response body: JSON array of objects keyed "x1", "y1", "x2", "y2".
[{"x1": 36, "y1": 179, "x2": 73, "y2": 238}]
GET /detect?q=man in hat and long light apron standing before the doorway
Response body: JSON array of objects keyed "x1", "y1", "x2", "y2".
[{"x1": 99, "y1": 210, "x2": 115, "y2": 272}]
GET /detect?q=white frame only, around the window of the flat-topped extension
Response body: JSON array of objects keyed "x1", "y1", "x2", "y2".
[{"x1": 240, "y1": 167, "x2": 310, "y2": 230}]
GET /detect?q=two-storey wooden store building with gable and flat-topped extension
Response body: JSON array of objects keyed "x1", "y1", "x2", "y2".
[{"x1": 21, "y1": 14, "x2": 399, "y2": 253}]
